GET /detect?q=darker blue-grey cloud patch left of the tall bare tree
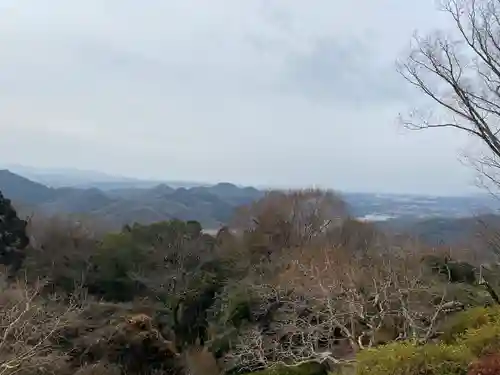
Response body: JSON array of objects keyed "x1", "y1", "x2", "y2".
[{"x1": 283, "y1": 37, "x2": 410, "y2": 106}]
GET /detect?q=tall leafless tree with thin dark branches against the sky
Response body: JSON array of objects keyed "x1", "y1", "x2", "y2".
[{"x1": 398, "y1": 0, "x2": 500, "y2": 194}]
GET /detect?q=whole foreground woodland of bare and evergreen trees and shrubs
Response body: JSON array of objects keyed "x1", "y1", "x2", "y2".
[{"x1": 0, "y1": 190, "x2": 500, "y2": 375}]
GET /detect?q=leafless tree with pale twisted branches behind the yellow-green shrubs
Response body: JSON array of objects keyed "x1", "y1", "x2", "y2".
[{"x1": 226, "y1": 248, "x2": 449, "y2": 371}]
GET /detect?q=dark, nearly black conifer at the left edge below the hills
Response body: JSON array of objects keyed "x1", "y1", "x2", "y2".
[{"x1": 0, "y1": 192, "x2": 29, "y2": 272}]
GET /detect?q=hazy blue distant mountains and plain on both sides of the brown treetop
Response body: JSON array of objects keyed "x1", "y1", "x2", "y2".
[{"x1": 0, "y1": 167, "x2": 500, "y2": 243}]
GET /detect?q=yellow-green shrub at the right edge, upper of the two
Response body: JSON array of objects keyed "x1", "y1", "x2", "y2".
[{"x1": 441, "y1": 306, "x2": 500, "y2": 344}]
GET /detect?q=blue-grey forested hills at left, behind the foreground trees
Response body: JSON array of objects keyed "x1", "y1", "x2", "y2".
[{"x1": 0, "y1": 170, "x2": 264, "y2": 229}]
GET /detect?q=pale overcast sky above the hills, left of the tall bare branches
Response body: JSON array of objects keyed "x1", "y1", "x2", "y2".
[{"x1": 0, "y1": 0, "x2": 482, "y2": 194}]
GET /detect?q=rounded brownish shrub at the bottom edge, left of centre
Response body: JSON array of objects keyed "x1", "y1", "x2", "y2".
[{"x1": 64, "y1": 303, "x2": 178, "y2": 374}]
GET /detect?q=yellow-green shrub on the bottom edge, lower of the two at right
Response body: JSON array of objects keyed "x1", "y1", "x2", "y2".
[{"x1": 357, "y1": 342, "x2": 473, "y2": 375}]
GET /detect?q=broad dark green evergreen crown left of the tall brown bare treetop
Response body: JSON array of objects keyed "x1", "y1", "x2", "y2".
[{"x1": 89, "y1": 220, "x2": 212, "y2": 301}]
